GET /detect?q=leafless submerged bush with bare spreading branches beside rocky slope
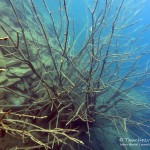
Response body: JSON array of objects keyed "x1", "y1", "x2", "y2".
[{"x1": 0, "y1": 0, "x2": 150, "y2": 150}]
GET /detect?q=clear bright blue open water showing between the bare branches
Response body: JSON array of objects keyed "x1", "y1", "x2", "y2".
[{"x1": 34, "y1": 0, "x2": 150, "y2": 150}]
